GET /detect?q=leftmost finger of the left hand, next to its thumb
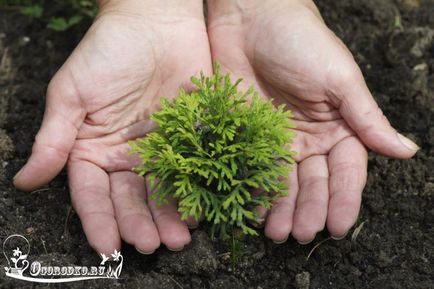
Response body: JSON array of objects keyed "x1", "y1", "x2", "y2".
[{"x1": 68, "y1": 160, "x2": 121, "y2": 254}]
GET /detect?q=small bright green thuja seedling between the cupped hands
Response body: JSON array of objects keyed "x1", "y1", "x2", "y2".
[{"x1": 130, "y1": 66, "x2": 294, "y2": 237}]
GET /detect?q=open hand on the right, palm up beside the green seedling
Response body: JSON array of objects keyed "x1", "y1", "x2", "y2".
[{"x1": 208, "y1": 0, "x2": 418, "y2": 244}]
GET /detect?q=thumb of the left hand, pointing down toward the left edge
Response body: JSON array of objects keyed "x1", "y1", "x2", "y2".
[{"x1": 14, "y1": 72, "x2": 85, "y2": 191}]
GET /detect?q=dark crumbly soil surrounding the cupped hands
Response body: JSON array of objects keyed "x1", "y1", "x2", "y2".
[{"x1": 0, "y1": 0, "x2": 434, "y2": 289}]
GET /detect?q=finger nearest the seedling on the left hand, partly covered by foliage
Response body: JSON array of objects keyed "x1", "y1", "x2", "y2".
[{"x1": 146, "y1": 176, "x2": 191, "y2": 251}]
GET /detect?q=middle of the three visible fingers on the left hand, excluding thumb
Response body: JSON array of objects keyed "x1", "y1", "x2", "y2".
[{"x1": 110, "y1": 171, "x2": 160, "y2": 254}]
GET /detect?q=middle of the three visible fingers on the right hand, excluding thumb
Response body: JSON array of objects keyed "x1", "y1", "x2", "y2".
[{"x1": 292, "y1": 156, "x2": 329, "y2": 244}]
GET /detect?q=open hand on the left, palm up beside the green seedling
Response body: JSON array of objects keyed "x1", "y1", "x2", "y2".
[{"x1": 14, "y1": 0, "x2": 211, "y2": 253}]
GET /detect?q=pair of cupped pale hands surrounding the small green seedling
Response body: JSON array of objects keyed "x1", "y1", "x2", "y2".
[{"x1": 14, "y1": 0, "x2": 418, "y2": 254}]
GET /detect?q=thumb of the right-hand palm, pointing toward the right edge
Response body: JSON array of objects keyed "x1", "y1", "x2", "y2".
[{"x1": 339, "y1": 64, "x2": 419, "y2": 159}]
